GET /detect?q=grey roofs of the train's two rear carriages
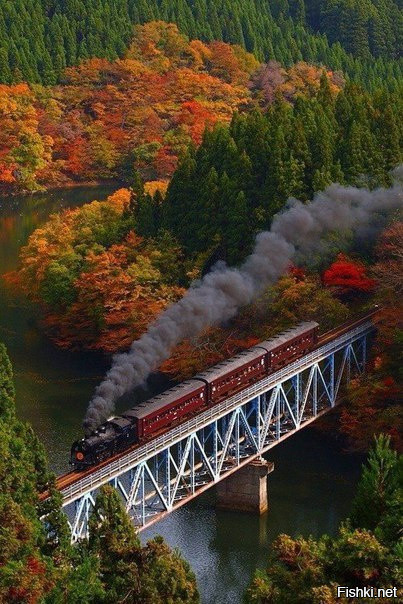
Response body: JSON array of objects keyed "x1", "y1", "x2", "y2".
[{"x1": 195, "y1": 321, "x2": 319, "y2": 382}]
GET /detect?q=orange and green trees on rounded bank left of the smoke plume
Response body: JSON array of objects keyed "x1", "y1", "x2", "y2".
[{"x1": 15, "y1": 188, "x2": 184, "y2": 352}]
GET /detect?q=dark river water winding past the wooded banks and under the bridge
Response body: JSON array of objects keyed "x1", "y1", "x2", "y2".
[{"x1": 0, "y1": 187, "x2": 361, "y2": 604}]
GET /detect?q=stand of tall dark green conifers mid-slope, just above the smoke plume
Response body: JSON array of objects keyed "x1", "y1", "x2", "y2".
[{"x1": 163, "y1": 84, "x2": 403, "y2": 263}]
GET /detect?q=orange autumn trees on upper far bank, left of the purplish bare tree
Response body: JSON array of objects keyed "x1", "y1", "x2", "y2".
[{"x1": 0, "y1": 21, "x2": 258, "y2": 190}]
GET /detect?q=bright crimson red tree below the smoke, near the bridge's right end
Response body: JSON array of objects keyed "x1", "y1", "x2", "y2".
[{"x1": 323, "y1": 254, "x2": 375, "y2": 295}]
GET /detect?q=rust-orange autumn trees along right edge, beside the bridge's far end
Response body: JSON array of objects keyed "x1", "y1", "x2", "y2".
[{"x1": 341, "y1": 222, "x2": 403, "y2": 449}]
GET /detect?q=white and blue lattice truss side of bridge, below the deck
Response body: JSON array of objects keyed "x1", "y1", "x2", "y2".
[{"x1": 64, "y1": 332, "x2": 368, "y2": 542}]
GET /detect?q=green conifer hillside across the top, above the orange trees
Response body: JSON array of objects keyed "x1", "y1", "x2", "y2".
[{"x1": 0, "y1": 0, "x2": 402, "y2": 89}]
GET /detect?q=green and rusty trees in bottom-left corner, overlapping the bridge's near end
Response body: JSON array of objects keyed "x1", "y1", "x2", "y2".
[{"x1": 0, "y1": 344, "x2": 199, "y2": 604}]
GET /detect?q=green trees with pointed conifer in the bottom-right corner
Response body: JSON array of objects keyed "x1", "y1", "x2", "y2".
[{"x1": 244, "y1": 434, "x2": 403, "y2": 604}]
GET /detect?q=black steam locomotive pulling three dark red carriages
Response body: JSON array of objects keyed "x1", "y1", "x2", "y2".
[{"x1": 70, "y1": 321, "x2": 319, "y2": 470}]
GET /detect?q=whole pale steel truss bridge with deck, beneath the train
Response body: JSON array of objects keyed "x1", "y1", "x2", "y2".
[{"x1": 59, "y1": 320, "x2": 374, "y2": 542}]
